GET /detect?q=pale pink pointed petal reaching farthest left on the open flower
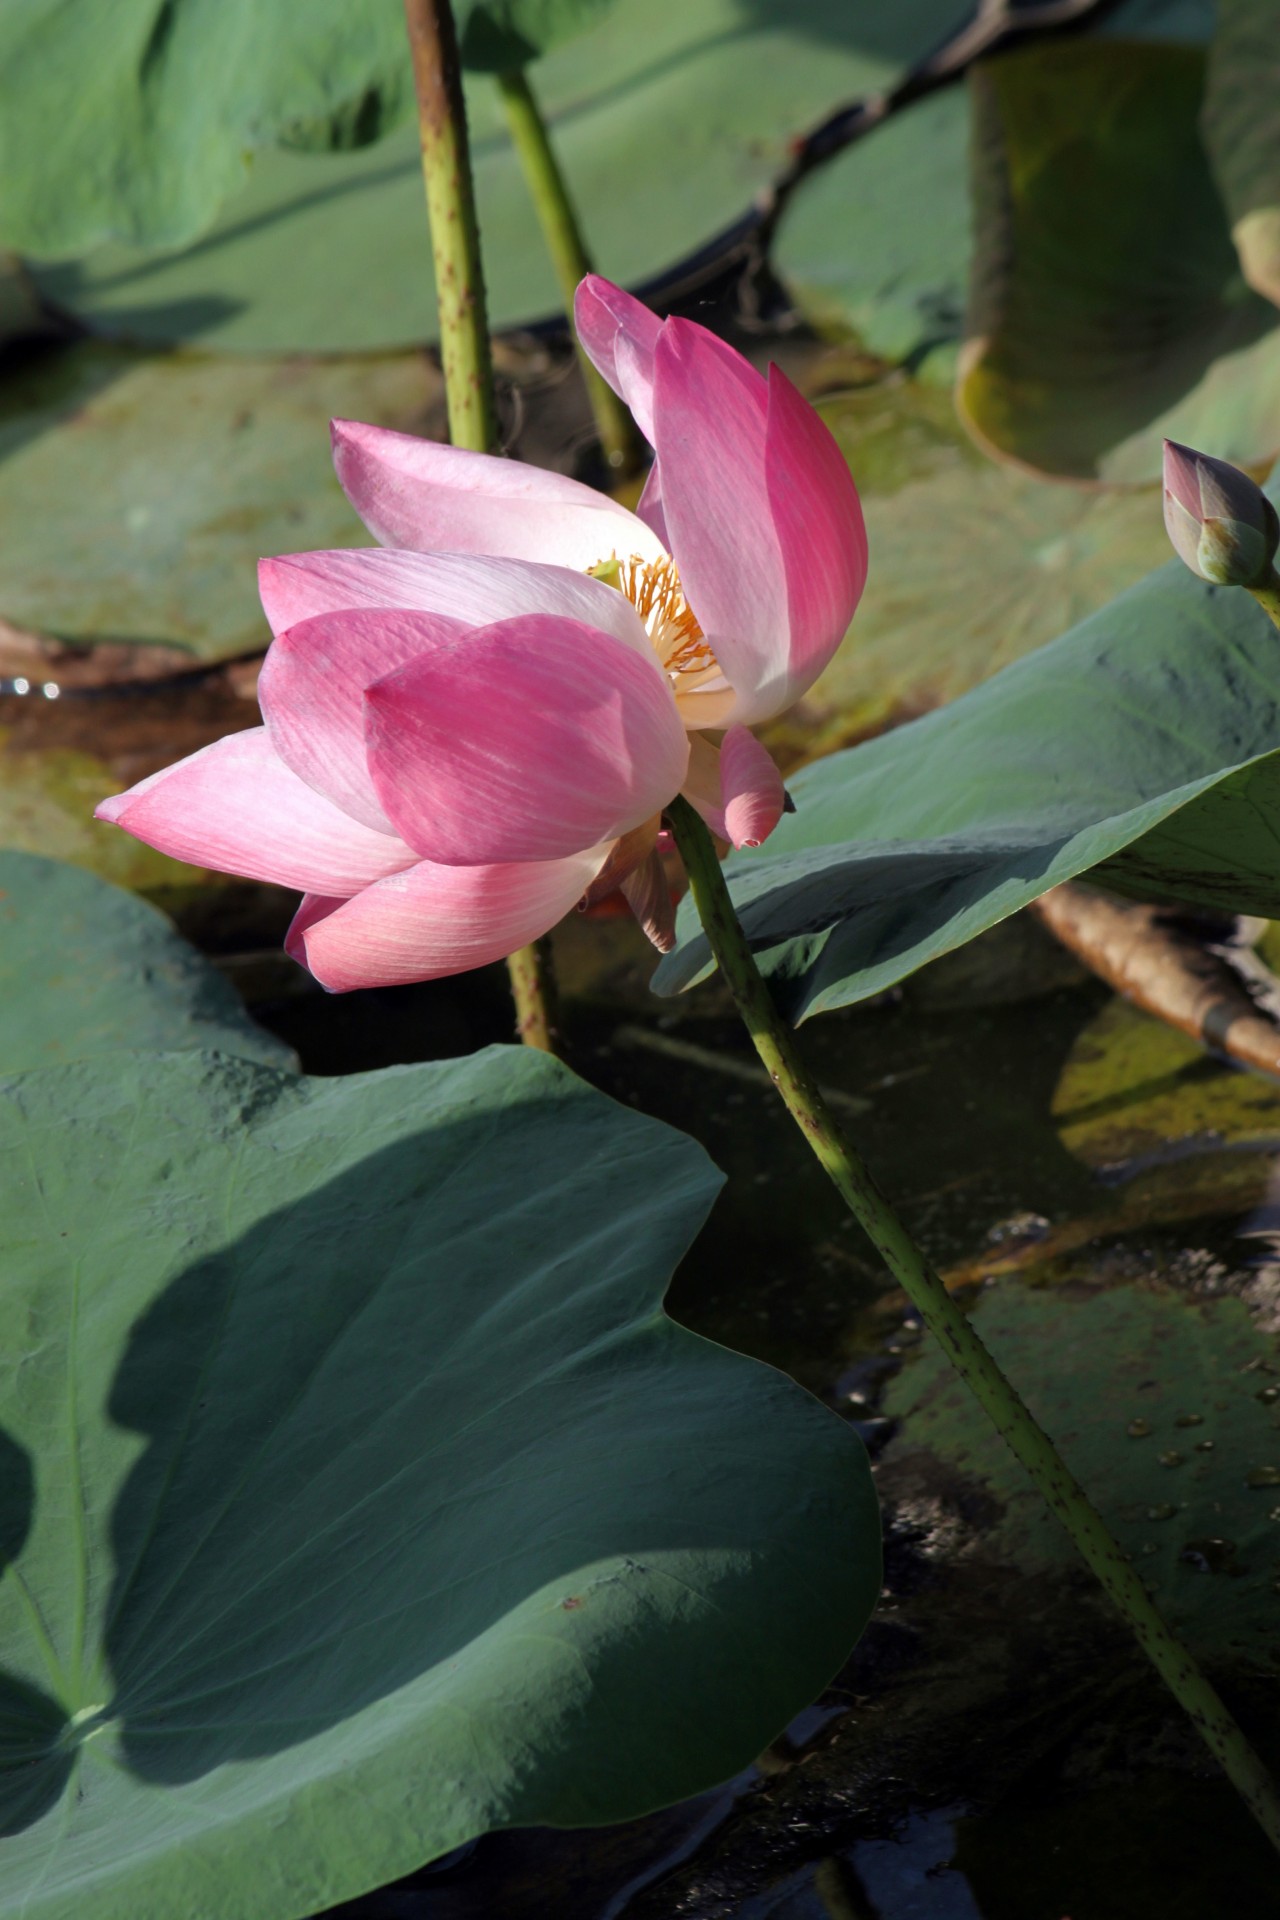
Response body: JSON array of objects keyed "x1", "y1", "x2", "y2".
[{"x1": 96, "y1": 726, "x2": 416, "y2": 899}]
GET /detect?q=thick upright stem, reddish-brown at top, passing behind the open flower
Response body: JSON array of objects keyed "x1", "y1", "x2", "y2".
[{"x1": 405, "y1": 0, "x2": 555, "y2": 1052}]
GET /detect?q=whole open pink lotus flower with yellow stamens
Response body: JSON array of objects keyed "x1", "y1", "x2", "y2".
[{"x1": 98, "y1": 276, "x2": 867, "y2": 991}]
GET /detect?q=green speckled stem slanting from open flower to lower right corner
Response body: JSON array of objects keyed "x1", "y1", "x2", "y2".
[{"x1": 666, "y1": 799, "x2": 1280, "y2": 1851}]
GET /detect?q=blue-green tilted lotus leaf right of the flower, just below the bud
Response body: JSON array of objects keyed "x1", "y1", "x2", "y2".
[{"x1": 654, "y1": 561, "x2": 1280, "y2": 1016}]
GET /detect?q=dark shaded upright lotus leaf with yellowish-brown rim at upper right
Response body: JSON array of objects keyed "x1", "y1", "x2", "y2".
[{"x1": 958, "y1": 40, "x2": 1280, "y2": 482}]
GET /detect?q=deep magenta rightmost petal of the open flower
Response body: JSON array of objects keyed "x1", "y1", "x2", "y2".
[{"x1": 764, "y1": 367, "x2": 867, "y2": 707}]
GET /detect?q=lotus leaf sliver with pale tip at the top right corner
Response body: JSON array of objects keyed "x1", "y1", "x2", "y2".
[{"x1": 1201, "y1": 0, "x2": 1280, "y2": 305}]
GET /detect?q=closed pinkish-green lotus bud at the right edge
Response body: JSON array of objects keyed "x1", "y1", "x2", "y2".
[{"x1": 1165, "y1": 440, "x2": 1280, "y2": 588}]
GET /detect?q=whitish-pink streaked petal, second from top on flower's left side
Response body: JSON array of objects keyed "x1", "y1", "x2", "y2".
[{"x1": 257, "y1": 545, "x2": 652, "y2": 659}]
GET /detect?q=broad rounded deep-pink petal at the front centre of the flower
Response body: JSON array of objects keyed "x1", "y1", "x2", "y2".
[{"x1": 365, "y1": 614, "x2": 689, "y2": 866}]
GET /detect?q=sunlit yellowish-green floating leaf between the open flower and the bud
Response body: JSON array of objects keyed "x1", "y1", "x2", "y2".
[{"x1": 770, "y1": 382, "x2": 1169, "y2": 764}]
